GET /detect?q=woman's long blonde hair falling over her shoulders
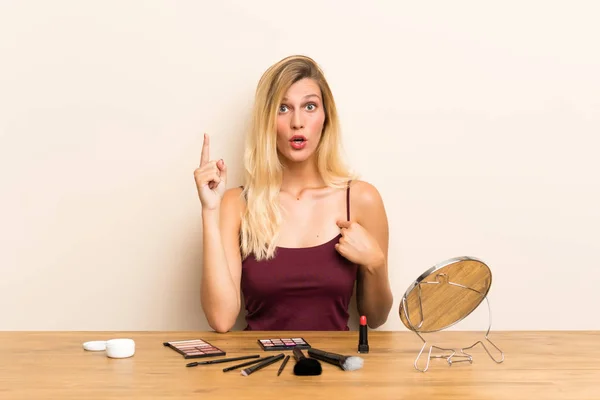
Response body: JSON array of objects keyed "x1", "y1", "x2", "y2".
[{"x1": 240, "y1": 55, "x2": 352, "y2": 260}]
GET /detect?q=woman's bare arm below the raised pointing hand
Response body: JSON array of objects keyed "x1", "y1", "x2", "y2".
[{"x1": 201, "y1": 188, "x2": 243, "y2": 333}]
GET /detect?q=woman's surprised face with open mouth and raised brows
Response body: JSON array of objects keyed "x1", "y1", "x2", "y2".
[{"x1": 277, "y1": 78, "x2": 325, "y2": 163}]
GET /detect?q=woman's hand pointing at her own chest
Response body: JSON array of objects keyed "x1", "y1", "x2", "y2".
[{"x1": 335, "y1": 220, "x2": 385, "y2": 270}]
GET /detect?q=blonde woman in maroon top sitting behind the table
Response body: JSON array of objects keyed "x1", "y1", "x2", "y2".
[{"x1": 194, "y1": 56, "x2": 392, "y2": 332}]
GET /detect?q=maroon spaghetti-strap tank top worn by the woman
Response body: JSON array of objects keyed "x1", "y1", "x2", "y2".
[{"x1": 241, "y1": 185, "x2": 358, "y2": 331}]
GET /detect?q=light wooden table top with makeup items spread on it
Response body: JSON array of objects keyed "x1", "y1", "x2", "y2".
[{"x1": 0, "y1": 331, "x2": 600, "y2": 400}]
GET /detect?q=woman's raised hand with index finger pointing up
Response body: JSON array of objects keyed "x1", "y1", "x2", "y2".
[{"x1": 194, "y1": 134, "x2": 227, "y2": 210}]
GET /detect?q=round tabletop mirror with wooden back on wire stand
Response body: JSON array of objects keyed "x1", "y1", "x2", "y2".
[{"x1": 399, "y1": 257, "x2": 504, "y2": 372}]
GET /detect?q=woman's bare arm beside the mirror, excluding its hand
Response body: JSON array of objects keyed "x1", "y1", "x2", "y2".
[{"x1": 350, "y1": 181, "x2": 393, "y2": 328}]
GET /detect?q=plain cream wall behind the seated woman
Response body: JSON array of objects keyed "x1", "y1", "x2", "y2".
[{"x1": 0, "y1": 0, "x2": 600, "y2": 330}]
